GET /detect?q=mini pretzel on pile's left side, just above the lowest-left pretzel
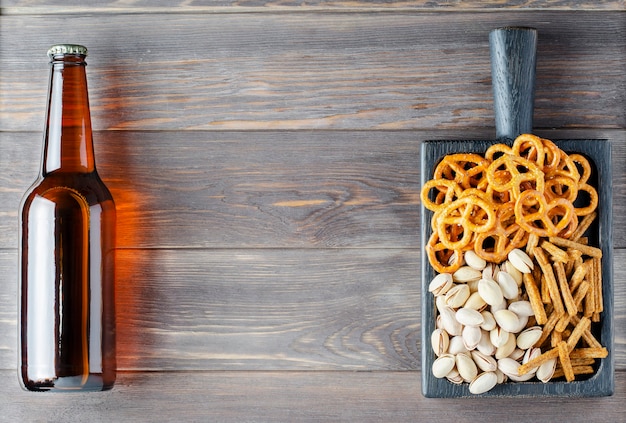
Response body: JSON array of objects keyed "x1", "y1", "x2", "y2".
[{"x1": 435, "y1": 195, "x2": 496, "y2": 250}]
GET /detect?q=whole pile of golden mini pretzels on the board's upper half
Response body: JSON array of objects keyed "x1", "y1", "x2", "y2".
[{"x1": 421, "y1": 134, "x2": 598, "y2": 273}]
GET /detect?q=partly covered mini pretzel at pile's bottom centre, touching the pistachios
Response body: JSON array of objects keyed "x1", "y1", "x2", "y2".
[{"x1": 474, "y1": 203, "x2": 529, "y2": 263}]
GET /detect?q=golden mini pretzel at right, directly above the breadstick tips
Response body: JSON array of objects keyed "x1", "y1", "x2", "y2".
[{"x1": 515, "y1": 190, "x2": 577, "y2": 237}]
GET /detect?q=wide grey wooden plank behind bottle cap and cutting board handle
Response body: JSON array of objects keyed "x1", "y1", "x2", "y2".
[{"x1": 0, "y1": 11, "x2": 626, "y2": 131}]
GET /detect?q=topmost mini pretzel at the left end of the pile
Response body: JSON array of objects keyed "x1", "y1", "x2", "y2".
[{"x1": 434, "y1": 153, "x2": 489, "y2": 188}]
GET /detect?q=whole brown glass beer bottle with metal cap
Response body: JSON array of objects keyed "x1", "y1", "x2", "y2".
[{"x1": 19, "y1": 44, "x2": 116, "y2": 391}]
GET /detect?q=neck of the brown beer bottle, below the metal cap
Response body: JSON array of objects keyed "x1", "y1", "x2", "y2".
[{"x1": 42, "y1": 54, "x2": 95, "y2": 176}]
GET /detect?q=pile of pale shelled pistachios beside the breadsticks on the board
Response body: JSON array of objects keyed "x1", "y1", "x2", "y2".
[{"x1": 428, "y1": 249, "x2": 556, "y2": 394}]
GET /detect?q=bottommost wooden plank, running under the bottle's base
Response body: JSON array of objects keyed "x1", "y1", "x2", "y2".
[{"x1": 0, "y1": 371, "x2": 626, "y2": 423}]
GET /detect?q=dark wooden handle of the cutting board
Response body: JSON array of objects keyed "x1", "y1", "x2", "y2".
[{"x1": 489, "y1": 27, "x2": 537, "y2": 140}]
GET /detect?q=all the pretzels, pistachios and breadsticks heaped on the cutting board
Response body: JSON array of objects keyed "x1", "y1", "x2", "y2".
[{"x1": 421, "y1": 134, "x2": 608, "y2": 393}]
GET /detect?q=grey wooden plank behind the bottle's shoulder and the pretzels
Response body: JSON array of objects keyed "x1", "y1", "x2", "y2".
[{"x1": 0, "y1": 130, "x2": 626, "y2": 252}]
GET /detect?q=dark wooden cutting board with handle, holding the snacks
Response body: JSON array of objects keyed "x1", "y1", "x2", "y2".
[{"x1": 421, "y1": 27, "x2": 614, "y2": 398}]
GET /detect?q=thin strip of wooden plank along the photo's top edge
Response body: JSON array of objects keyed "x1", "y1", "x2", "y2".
[{"x1": 2, "y1": 0, "x2": 624, "y2": 14}]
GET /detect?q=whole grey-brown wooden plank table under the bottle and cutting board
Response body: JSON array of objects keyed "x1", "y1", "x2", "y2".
[{"x1": 0, "y1": 0, "x2": 626, "y2": 422}]
